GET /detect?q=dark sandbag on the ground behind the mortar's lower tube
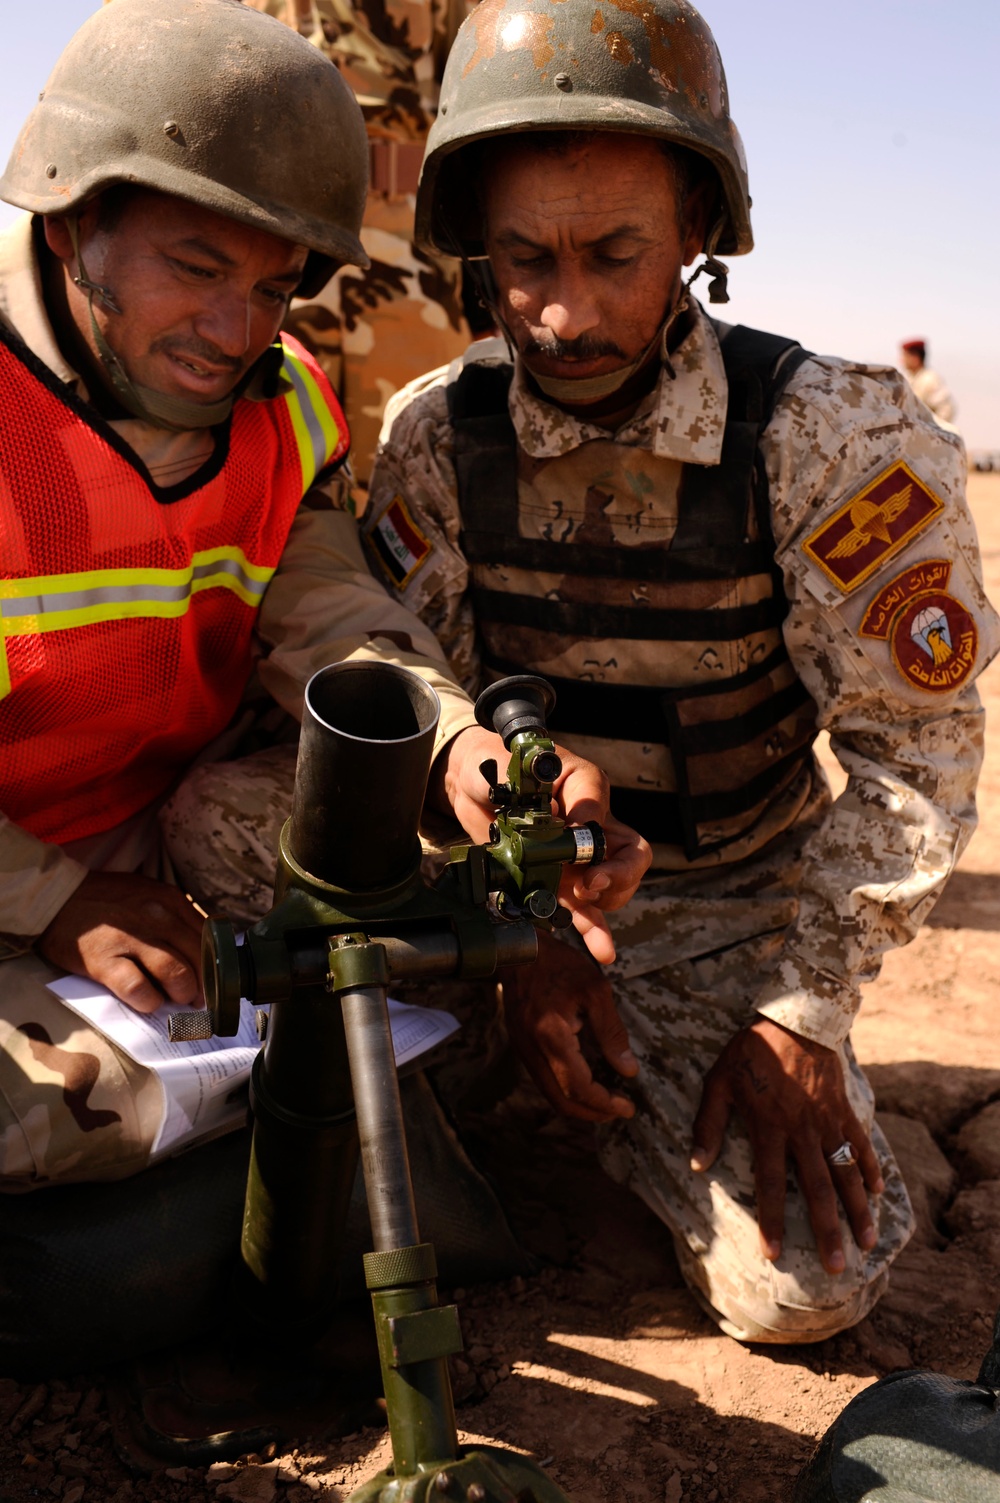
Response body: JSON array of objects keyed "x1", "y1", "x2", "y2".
[{"x1": 0, "y1": 1073, "x2": 531, "y2": 1377}]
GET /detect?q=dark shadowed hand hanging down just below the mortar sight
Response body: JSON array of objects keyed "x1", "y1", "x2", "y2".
[{"x1": 502, "y1": 933, "x2": 639, "y2": 1123}]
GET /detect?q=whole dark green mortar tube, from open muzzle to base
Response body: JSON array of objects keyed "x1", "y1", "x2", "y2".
[{"x1": 242, "y1": 663, "x2": 441, "y2": 1339}]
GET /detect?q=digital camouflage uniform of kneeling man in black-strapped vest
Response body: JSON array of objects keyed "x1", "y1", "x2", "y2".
[{"x1": 364, "y1": 305, "x2": 1000, "y2": 1341}]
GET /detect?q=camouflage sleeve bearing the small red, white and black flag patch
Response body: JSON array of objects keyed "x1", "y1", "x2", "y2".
[{"x1": 362, "y1": 367, "x2": 481, "y2": 694}]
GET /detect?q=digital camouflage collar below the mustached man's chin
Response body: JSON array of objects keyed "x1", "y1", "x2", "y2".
[{"x1": 510, "y1": 299, "x2": 728, "y2": 464}]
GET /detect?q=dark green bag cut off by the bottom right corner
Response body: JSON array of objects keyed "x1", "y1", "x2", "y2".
[{"x1": 794, "y1": 1317, "x2": 1000, "y2": 1503}]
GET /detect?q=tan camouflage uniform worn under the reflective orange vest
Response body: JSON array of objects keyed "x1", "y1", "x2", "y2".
[{"x1": 0, "y1": 216, "x2": 475, "y2": 1190}]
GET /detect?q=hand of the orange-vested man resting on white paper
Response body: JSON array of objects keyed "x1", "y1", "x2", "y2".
[{"x1": 36, "y1": 872, "x2": 205, "y2": 1013}]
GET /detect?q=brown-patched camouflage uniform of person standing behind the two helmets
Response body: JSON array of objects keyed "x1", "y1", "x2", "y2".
[{"x1": 244, "y1": 0, "x2": 474, "y2": 489}]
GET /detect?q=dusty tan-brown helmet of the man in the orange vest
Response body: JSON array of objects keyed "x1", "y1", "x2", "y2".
[{"x1": 0, "y1": 0, "x2": 368, "y2": 296}]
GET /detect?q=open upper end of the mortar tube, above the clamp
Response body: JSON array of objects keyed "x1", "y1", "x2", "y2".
[{"x1": 289, "y1": 663, "x2": 441, "y2": 893}]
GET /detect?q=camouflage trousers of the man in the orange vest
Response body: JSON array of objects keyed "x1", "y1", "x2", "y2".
[{"x1": 0, "y1": 745, "x2": 296, "y2": 1192}]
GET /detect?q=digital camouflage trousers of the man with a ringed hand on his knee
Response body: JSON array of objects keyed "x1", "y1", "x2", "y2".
[{"x1": 602, "y1": 834, "x2": 914, "y2": 1342}]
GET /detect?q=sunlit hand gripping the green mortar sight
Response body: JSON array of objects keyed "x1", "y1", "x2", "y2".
[{"x1": 432, "y1": 726, "x2": 653, "y2": 965}]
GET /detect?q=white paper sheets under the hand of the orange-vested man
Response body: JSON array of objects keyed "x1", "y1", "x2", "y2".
[{"x1": 48, "y1": 975, "x2": 459, "y2": 1163}]
